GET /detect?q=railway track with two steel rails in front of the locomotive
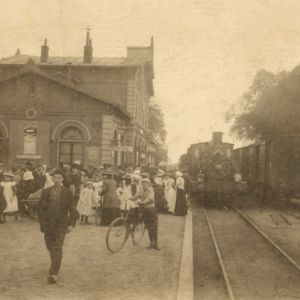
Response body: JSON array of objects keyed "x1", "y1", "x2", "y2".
[{"x1": 204, "y1": 209, "x2": 300, "y2": 300}]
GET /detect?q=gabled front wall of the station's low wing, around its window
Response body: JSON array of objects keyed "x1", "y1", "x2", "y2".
[{"x1": 0, "y1": 73, "x2": 127, "y2": 167}]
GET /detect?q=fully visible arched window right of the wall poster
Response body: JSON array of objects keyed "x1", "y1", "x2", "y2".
[{"x1": 59, "y1": 126, "x2": 85, "y2": 165}]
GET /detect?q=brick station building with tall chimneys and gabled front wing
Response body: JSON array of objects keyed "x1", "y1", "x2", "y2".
[{"x1": 0, "y1": 32, "x2": 155, "y2": 167}]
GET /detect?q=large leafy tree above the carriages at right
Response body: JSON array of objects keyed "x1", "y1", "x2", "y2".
[{"x1": 227, "y1": 67, "x2": 300, "y2": 140}]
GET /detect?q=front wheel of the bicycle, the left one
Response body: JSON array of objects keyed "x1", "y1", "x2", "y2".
[{"x1": 106, "y1": 217, "x2": 129, "y2": 253}]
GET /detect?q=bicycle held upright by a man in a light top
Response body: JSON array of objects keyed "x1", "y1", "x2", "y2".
[{"x1": 106, "y1": 202, "x2": 146, "y2": 253}]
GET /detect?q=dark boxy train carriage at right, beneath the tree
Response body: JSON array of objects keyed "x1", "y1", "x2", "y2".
[{"x1": 234, "y1": 134, "x2": 300, "y2": 200}]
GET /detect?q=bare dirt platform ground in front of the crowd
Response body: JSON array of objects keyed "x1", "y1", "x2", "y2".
[{"x1": 0, "y1": 215, "x2": 185, "y2": 300}]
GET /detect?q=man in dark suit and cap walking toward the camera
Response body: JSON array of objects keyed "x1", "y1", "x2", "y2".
[{"x1": 39, "y1": 170, "x2": 78, "y2": 284}]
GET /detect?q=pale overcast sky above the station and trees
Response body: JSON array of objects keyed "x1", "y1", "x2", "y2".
[{"x1": 0, "y1": 0, "x2": 300, "y2": 161}]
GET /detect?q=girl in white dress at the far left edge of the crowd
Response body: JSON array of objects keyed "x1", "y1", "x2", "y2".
[{"x1": 0, "y1": 172, "x2": 18, "y2": 213}]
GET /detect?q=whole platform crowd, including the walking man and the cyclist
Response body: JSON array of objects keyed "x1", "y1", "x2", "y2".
[{"x1": 0, "y1": 163, "x2": 192, "y2": 284}]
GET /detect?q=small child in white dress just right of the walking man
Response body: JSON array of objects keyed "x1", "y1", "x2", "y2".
[{"x1": 77, "y1": 181, "x2": 96, "y2": 224}]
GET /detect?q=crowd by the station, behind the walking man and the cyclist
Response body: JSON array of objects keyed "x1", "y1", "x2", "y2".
[{"x1": 0, "y1": 162, "x2": 189, "y2": 226}]
